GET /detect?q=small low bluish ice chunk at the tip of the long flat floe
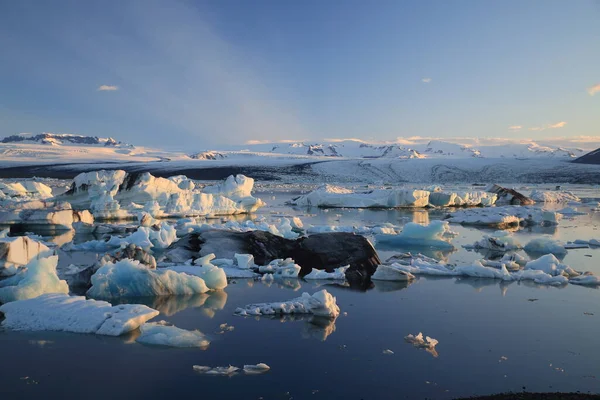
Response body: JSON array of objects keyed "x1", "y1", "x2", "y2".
[{"x1": 135, "y1": 321, "x2": 210, "y2": 348}]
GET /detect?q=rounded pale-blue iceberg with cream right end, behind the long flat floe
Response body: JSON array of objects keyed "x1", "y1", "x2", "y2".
[{"x1": 87, "y1": 259, "x2": 209, "y2": 299}]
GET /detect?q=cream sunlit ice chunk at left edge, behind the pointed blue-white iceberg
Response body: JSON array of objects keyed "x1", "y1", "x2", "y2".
[{"x1": 0, "y1": 236, "x2": 52, "y2": 276}]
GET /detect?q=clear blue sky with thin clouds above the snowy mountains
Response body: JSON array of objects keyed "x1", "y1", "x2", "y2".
[{"x1": 0, "y1": 0, "x2": 600, "y2": 149}]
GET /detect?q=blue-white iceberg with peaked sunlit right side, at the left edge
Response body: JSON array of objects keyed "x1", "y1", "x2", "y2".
[{"x1": 0, "y1": 256, "x2": 69, "y2": 303}]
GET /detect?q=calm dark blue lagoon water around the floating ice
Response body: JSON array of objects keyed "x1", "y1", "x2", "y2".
[{"x1": 0, "y1": 187, "x2": 600, "y2": 399}]
